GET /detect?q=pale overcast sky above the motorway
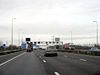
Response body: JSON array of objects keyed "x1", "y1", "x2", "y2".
[{"x1": 0, "y1": 0, "x2": 100, "y2": 44}]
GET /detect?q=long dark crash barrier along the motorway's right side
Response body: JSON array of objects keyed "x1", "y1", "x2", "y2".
[{"x1": 58, "y1": 49, "x2": 100, "y2": 56}]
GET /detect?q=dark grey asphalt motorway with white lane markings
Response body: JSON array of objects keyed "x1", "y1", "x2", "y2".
[{"x1": 0, "y1": 50, "x2": 100, "y2": 75}]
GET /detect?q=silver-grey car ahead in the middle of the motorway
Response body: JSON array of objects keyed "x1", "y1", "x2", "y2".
[{"x1": 44, "y1": 46, "x2": 58, "y2": 57}]
